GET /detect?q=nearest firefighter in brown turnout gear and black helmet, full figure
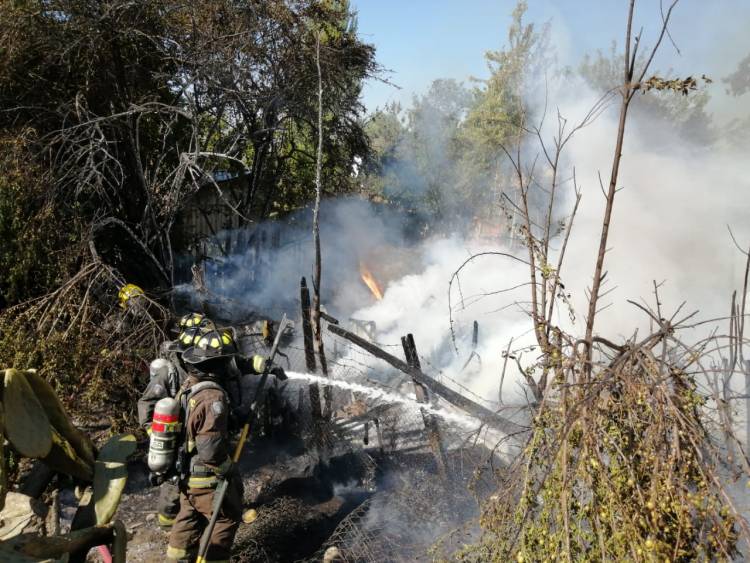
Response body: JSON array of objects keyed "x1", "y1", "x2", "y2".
[{"x1": 167, "y1": 330, "x2": 242, "y2": 563}]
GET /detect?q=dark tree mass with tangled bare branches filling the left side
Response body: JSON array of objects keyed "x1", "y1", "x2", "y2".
[{"x1": 0, "y1": 0, "x2": 376, "y2": 424}]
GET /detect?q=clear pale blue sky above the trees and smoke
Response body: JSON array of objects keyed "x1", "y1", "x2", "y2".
[{"x1": 352, "y1": 0, "x2": 750, "y2": 116}]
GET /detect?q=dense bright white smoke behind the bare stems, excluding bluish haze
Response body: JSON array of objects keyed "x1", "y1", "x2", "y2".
[{"x1": 346, "y1": 78, "x2": 750, "y2": 403}]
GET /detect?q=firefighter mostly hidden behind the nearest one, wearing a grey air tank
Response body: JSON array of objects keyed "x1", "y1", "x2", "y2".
[{"x1": 138, "y1": 313, "x2": 214, "y2": 530}]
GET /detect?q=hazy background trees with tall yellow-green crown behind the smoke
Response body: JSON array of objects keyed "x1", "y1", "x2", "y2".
[{"x1": 363, "y1": 2, "x2": 547, "y2": 231}]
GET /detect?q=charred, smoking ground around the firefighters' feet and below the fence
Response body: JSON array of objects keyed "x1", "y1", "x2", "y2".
[{"x1": 108, "y1": 430, "x2": 490, "y2": 563}]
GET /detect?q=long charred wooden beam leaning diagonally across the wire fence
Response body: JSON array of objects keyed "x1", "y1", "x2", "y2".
[{"x1": 328, "y1": 325, "x2": 524, "y2": 434}]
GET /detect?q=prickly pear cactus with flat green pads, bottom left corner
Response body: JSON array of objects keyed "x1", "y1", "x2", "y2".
[{"x1": 0, "y1": 369, "x2": 136, "y2": 563}]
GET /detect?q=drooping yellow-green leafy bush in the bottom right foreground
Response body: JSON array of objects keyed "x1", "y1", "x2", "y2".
[{"x1": 461, "y1": 350, "x2": 738, "y2": 562}]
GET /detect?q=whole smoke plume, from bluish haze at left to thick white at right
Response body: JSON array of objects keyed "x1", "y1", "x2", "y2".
[{"x1": 181, "y1": 77, "x2": 750, "y2": 416}]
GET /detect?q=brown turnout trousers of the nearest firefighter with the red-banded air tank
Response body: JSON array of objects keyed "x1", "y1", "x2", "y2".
[{"x1": 167, "y1": 477, "x2": 243, "y2": 563}]
